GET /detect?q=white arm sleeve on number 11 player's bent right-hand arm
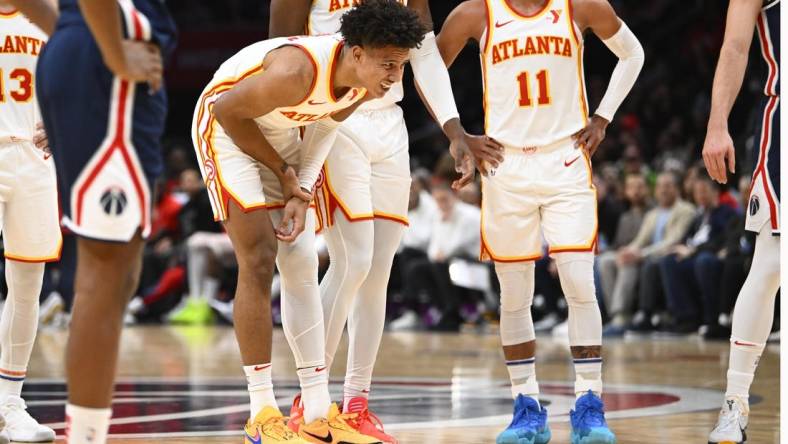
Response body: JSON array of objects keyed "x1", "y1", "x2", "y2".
[{"x1": 595, "y1": 22, "x2": 645, "y2": 122}]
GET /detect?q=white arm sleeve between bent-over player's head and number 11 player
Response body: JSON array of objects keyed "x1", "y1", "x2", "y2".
[{"x1": 410, "y1": 32, "x2": 460, "y2": 127}]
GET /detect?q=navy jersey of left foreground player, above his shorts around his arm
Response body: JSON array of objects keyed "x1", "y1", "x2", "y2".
[{"x1": 57, "y1": 0, "x2": 176, "y2": 60}]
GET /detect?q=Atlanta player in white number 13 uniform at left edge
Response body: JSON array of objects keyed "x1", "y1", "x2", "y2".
[{"x1": 0, "y1": 1, "x2": 62, "y2": 442}]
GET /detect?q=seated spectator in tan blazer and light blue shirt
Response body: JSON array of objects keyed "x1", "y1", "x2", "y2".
[{"x1": 606, "y1": 173, "x2": 695, "y2": 335}]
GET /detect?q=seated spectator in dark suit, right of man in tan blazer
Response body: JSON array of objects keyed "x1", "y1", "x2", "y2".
[{"x1": 660, "y1": 175, "x2": 736, "y2": 334}]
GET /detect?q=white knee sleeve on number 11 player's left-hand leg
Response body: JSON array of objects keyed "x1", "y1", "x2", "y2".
[{"x1": 495, "y1": 262, "x2": 536, "y2": 346}]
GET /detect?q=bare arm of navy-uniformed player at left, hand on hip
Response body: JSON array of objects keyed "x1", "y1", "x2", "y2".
[{"x1": 79, "y1": 0, "x2": 163, "y2": 91}]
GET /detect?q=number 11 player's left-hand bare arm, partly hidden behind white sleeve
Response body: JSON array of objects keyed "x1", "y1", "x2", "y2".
[{"x1": 436, "y1": 0, "x2": 503, "y2": 176}]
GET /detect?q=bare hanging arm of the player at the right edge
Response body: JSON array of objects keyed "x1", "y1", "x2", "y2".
[{"x1": 703, "y1": 0, "x2": 763, "y2": 183}]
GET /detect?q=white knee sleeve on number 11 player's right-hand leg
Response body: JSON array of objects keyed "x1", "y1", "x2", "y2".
[{"x1": 555, "y1": 253, "x2": 602, "y2": 346}]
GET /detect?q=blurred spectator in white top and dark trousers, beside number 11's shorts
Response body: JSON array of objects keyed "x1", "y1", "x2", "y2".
[{"x1": 404, "y1": 183, "x2": 481, "y2": 331}]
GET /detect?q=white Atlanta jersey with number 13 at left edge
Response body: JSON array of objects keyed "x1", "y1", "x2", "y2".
[{"x1": 0, "y1": 11, "x2": 47, "y2": 141}]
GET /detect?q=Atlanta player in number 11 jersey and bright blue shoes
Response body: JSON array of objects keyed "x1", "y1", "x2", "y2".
[{"x1": 438, "y1": 0, "x2": 644, "y2": 444}]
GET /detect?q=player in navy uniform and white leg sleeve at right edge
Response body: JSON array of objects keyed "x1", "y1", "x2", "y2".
[{"x1": 703, "y1": 0, "x2": 780, "y2": 444}]
